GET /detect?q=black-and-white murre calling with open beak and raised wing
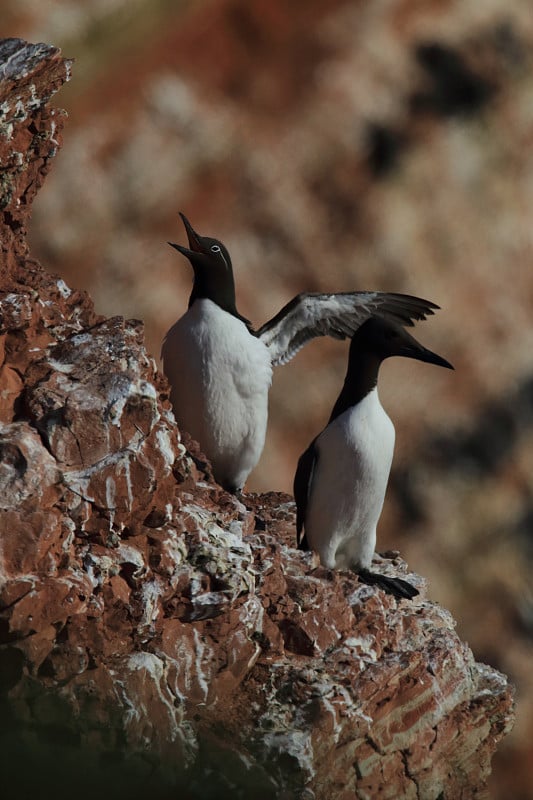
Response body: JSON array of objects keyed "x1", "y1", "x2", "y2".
[{"x1": 161, "y1": 214, "x2": 438, "y2": 492}]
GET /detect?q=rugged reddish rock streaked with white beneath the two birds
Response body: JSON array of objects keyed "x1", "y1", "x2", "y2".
[{"x1": 0, "y1": 40, "x2": 513, "y2": 800}]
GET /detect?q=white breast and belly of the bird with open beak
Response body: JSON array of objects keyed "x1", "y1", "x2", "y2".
[{"x1": 162, "y1": 299, "x2": 272, "y2": 491}]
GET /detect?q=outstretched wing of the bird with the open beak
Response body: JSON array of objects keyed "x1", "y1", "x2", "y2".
[{"x1": 256, "y1": 292, "x2": 439, "y2": 365}]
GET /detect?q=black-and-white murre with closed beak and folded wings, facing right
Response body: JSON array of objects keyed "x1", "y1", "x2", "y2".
[{"x1": 294, "y1": 317, "x2": 453, "y2": 598}]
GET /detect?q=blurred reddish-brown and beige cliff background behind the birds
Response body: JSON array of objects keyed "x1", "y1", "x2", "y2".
[{"x1": 4, "y1": 0, "x2": 533, "y2": 800}]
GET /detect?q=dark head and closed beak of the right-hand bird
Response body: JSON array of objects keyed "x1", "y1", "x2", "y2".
[{"x1": 350, "y1": 317, "x2": 453, "y2": 369}]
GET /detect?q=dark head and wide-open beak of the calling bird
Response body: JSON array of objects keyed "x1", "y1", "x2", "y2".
[{"x1": 168, "y1": 212, "x2": 236, "y2": 314}]
